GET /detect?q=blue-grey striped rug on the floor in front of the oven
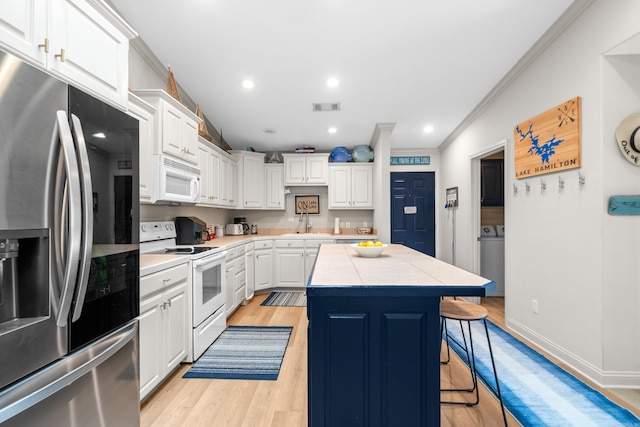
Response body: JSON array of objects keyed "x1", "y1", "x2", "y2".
[{"x1": 183, "y1": 326, "x2": 293, "y2": 380}]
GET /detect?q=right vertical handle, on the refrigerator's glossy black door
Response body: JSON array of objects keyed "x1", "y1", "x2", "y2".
[{"x1": 71, "y1": 114, "x2": 93, "y2": 322}]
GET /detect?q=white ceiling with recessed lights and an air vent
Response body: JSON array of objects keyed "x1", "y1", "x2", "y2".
[{"x1": 111, "y1": 0, "x2": 573, "y2": 152}]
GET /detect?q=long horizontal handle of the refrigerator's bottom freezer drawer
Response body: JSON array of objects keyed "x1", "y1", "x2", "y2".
[{"x1": 0, "y1": 320, "x2": 138, "y2": 424}]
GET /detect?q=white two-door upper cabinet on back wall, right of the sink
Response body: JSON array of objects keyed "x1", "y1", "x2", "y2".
[{"x1": 329, "y1": 163, "x2": 373, "y2": 209}]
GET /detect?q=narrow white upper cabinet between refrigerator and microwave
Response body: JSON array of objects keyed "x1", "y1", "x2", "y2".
[{"x1": 128, "y1": 93, "x2": 156, "y2": 203}]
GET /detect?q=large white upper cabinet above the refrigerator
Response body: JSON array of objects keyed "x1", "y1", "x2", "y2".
[{"x1": 0, "y1": 0, "x2": 136, "y2": 109}]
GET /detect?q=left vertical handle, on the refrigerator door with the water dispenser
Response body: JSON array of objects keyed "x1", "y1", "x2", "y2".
[{"x1": 56, "y1": 110, "x2": 82, "y2": 328}]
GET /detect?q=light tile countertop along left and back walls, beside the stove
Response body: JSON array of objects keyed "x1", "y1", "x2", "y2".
[{"x1": 140, "y1": 229, "x2": 378, "y2": 277}]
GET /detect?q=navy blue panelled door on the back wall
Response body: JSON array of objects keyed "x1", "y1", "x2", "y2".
[{"x1": 391, "y1": 172, "x2": 436, "y2": 256}]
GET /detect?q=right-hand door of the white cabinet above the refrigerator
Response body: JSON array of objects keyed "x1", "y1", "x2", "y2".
[{"x1": 47, "y1": 0, "x2": 129, "y2": 107}]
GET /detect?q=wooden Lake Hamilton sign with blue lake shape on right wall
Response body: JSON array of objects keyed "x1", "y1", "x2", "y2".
[{"x1": 513, "y1": 96, "x2": 582, "y2": 179}]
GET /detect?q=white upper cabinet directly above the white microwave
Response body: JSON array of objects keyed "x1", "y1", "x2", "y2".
[{"x1": 134, "y1": 89, "x2": 200, "y2": 164}]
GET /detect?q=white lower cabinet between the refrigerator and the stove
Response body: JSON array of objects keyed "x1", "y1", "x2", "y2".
[{"x1": 139, "y1": 264, "x2": 191, "y2": 400}]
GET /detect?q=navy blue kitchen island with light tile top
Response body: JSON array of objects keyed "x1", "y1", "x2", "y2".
[{"x1": 307, "y1": 244, "x2": 495, "y2": 427}]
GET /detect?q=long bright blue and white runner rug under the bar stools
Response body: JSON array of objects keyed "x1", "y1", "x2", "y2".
[{"x1": 447, "y1": 320, "x2": 640, "y2": 427}]
